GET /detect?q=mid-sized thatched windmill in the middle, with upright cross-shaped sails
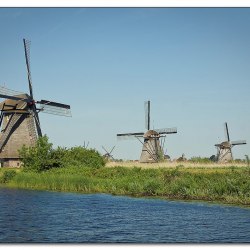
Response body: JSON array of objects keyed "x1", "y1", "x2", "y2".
[{"x1": 117, "y1": 101, "x2": 177, "y2": 163}]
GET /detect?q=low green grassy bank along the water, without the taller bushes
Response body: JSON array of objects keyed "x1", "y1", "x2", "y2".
[{"x1": 0, "y1": 166, "x2": 250, "y2": 205}]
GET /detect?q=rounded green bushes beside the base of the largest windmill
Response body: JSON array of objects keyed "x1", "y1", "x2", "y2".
[{"x1": 19, "y1": 135, "x2": 105, "y2": 172}]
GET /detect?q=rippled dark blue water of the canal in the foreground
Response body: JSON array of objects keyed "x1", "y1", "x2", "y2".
[{"x1": 0, "y1": 189, "x2": 250, "y2": 243}]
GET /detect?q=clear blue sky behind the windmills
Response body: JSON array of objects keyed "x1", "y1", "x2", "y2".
[{"x1": 0, "y1": 8, "x2": 250, "y2": 159}]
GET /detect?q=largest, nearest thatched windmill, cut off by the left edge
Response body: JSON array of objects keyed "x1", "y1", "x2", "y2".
[{"x1": 0, "y1": 39, "x2": 71, "y2": 167}]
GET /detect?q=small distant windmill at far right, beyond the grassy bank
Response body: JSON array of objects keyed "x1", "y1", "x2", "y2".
[{"x1": 215, "y1": 122, "x2": 247, "y2": 162}]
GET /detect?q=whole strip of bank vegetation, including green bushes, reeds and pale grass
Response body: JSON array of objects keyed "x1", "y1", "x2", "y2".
[{"x1": 0, "y1": 137, "x2": 250, "y2": 206}]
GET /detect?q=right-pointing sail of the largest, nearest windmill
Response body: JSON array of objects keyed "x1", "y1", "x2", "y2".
[{"x1": 37, "y1": 100, "x2": 72, "y2": 116}]
